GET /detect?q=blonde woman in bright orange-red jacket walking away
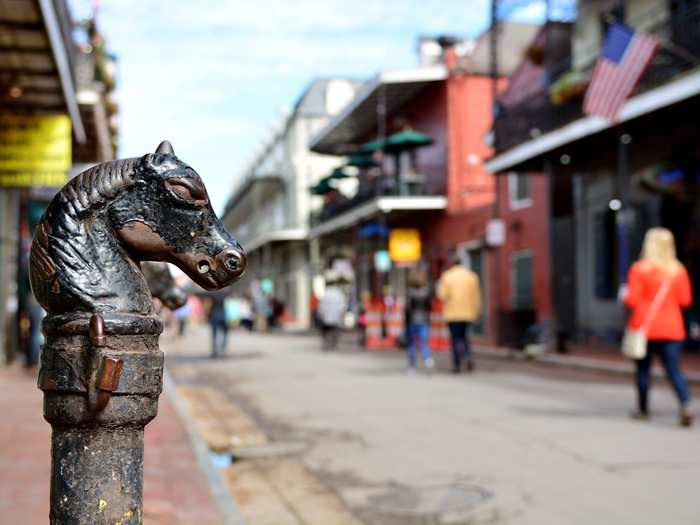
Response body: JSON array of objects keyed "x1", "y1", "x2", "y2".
[{"x1": 625, "y1": 228, "x2": 693, "y2": 426}]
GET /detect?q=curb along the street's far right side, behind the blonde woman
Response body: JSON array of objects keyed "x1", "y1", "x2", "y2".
[{"x1": 474, "y1": 347, "x2": 700, "y2": 386}]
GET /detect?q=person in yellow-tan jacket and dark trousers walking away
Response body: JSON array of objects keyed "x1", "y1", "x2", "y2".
[{"x1": 437, "y1": 254, "x2": 482, "y2": 374}]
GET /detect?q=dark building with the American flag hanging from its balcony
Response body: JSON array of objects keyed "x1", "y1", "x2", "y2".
[{"x1": 488, "y1": 0, "x2": 700, "y2": 345}]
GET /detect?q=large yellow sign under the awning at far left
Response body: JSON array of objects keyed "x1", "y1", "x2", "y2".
[{"x1": 0, "y1": 115, "x2": 71, "y2": 186}]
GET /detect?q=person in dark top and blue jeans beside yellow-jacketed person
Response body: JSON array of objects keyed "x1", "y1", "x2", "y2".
[{"x1": 406, "y1": 270, "x2": 435, "y2": 371}]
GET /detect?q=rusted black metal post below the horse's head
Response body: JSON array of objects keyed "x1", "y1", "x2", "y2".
[{"x1": 39, "y1": 314, "x2": 163, "y2": 525}]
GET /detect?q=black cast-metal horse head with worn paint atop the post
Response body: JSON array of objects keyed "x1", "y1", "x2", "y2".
[{"x1": 29, "y1": 141, "x2": 246, "y2": 315}]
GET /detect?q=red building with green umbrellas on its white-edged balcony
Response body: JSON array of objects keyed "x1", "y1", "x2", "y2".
[{"x1": 310, "y1": 23, "x2": 551, "y2": 344}]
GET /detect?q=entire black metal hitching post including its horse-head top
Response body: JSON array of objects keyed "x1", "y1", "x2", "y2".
[{"x1": 30, "y1": 142, "x2": 246, "y2": 525}]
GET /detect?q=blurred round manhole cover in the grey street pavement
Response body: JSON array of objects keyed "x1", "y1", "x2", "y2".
[{"x1": 370, "y1": 483, "x2": 493, "y2": 516}]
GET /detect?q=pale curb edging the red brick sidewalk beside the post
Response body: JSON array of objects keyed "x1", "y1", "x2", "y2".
[{"x1": 163, "y1": 369, "x2": 245, "y2": 525}]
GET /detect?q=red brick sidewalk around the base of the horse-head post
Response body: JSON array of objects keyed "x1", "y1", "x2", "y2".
[{"x1": 0, "y1": 365, "x2": 223, "y2": 525}]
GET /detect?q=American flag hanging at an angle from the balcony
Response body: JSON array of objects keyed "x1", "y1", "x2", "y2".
[{"x1": 583, "y1": 24, "x2": 659, "y2": 121}]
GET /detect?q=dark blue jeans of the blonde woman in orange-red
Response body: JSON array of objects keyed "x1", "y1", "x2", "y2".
[{"x1": 637, "y1": 341, "x2": 690, "y2": 413}]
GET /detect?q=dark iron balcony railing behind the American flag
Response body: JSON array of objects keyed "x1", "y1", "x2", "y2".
[{"x1": 494, "y1": 3, "x2": 700, "y2": 155}]
